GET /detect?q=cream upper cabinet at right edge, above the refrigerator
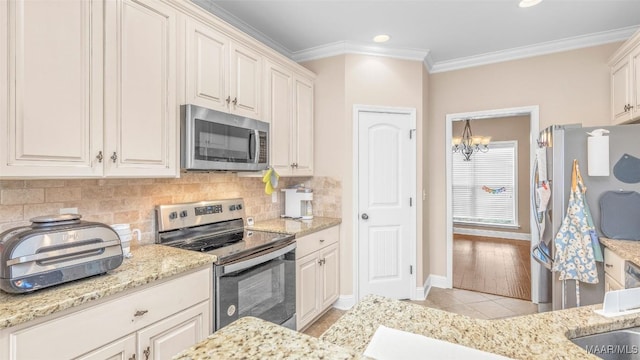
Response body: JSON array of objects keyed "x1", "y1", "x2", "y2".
[{"x1": 609, "y1": 28, "x2": 640, "y2": 125}]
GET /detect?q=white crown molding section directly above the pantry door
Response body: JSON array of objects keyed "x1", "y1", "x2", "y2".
[{"x1": 291, "y1": 41, "x2": 429, "y2": 62}]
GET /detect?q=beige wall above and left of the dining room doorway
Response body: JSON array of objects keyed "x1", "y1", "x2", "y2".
[{"x1": 425, "y1": 43, "x2": 620, "y2": 276}]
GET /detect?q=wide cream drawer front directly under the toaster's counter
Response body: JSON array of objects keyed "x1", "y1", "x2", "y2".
[{"x1": 9, "y1": 268, "x2": 212, "y2": 359}]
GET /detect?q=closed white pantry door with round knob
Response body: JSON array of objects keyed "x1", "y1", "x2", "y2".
[{"x1": 357, "y1": 110, "x2": 416, "y2": 299}]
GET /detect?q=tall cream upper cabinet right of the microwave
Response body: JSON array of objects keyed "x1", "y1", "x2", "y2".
[{"x1": 265, "y1": 62, "x2": 313, "y2": 176}]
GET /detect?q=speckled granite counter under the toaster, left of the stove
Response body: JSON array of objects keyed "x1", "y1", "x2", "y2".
[{"x1": 0, "y1": 245, "x2": 215, "y2": 329}]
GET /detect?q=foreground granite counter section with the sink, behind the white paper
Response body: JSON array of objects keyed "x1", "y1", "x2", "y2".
[{"x1": 321, "y1": 296, "x2": 640, "y2": 359}]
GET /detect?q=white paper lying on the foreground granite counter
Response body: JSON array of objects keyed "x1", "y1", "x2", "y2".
[{"x1": 364, "y1": 325, "x2": 509, "y2": 360}]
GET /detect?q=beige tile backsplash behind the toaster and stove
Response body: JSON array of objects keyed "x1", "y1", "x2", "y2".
[{"x1": 0, "y1": 172, "x2": 341, "y2": 244}]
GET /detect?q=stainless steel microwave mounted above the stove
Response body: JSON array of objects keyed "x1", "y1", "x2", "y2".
[{"x1": 180, "y1": 105, "x2": 269, "y2": 171}]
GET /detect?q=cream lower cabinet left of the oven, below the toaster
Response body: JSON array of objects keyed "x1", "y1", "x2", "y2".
[{"x1": 0, "y1": 266, "x2": 213, "y2": 360}]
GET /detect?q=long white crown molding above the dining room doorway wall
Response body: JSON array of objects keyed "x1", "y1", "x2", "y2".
[{"x1": 427, "y1": 26, "x2": 640, "y2": 74}]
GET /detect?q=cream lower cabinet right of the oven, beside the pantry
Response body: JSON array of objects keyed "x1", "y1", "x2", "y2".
[{"x1": 296, "y1": 226, "x2": 340, "y2": 330}]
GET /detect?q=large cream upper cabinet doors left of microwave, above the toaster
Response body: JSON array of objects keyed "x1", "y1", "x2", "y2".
[{"x1": 0, "y1": 0, "x2": 179, "y2": 178}]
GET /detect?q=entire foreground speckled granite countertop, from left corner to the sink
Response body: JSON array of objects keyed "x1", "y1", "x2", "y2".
[{"x1": 174, "y1": 295, "x2": 640, "y2": 360}]
